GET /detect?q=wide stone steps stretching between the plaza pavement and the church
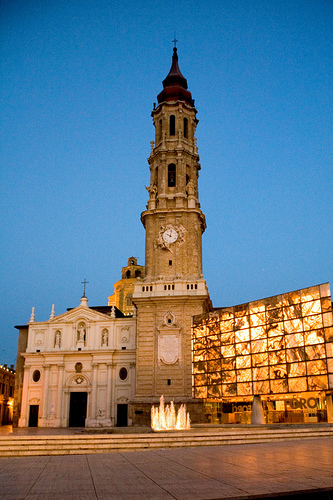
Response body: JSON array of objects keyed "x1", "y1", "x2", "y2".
[{"x1": 0, "y1": 427, "x2": 333, "y2": 457}]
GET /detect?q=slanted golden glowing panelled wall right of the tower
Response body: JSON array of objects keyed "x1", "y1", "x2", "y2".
[{"x1": 192, "y1": 283, "x2": 333, "y2": 399}]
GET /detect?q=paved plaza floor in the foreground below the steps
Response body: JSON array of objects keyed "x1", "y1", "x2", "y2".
[{"x1": 0, "y1": 429, "x2": 333, "y2": 500}]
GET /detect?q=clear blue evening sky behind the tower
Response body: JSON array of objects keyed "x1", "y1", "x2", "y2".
[{"x1": 0, "y1": 0, "x2": 333, "y2": 364}]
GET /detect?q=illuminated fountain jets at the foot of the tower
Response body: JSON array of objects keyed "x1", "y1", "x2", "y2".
[{"x1": 151, "y1": 396, "x2": 191, "y2": 431}]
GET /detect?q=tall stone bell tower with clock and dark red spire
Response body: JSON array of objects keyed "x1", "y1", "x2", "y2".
[{"x1": 132, "y1": 47, "x2": 210, "y2": 424}]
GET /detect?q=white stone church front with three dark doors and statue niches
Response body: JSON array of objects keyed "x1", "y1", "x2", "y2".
[{"x1": 18, "y1": 297, "x2": 136, "y2": 427}]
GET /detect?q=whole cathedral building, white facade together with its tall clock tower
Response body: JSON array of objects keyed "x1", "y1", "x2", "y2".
[{"x1": 14, "y1": 48, "x2": 211, "y2": 427}]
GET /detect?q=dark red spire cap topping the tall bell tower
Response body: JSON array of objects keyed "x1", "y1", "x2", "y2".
[{"x1": 157, "y1": 47, "x2": 194, "y2": 106}]
